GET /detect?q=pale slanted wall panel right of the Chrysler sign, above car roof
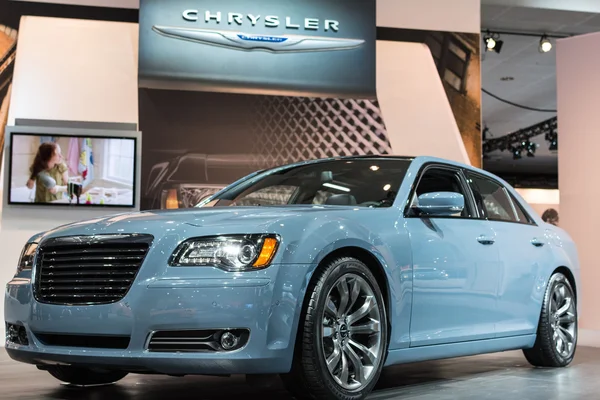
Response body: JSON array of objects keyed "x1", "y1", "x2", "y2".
[{"x1": 377, "y1": 42, "x2": 470, "y2": 164}]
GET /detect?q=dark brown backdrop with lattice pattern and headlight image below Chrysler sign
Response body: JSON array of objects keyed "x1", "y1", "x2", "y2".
[{"x1": 140, "y1": 91, "x2": 392, "y2": 209}]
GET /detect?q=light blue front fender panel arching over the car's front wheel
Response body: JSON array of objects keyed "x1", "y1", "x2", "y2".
[{"x1": 268, "y1": 209, "x2": 412, "y2": 348}]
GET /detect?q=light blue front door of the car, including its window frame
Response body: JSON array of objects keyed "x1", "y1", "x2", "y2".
[{"x1": 405, "y1": 164, "x2": 500, "y2": 347}]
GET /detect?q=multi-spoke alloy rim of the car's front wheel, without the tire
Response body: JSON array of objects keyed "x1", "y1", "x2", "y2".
[{"x1": 322, "y1": 274, "x2": 385, "y2": 391}]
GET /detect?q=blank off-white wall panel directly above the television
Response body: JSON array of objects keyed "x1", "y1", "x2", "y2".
[{"x1": 8, "y1": 17, "x2": 138, "y2": 125}]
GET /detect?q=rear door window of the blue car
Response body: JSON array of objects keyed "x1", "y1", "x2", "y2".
[{"x1": 467, "y1": 173, "x2": 519, "y2": 222}]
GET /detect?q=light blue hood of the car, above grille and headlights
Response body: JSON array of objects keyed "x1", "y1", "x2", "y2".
[{"x1": 36, "y1": 206, "x2": 358, "y2": 238}]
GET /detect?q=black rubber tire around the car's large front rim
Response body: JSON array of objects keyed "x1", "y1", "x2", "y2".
[{"x1": 281, "y1": 257, "x2": 389, "y2": 400}]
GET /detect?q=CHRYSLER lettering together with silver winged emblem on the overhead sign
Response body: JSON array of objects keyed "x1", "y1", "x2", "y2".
[{"x1": 152, "y1": 10, "x2": 365, "y2": 53}]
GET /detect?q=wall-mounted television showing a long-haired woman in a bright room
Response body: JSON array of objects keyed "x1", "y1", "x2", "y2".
[{"x1": 8, "y1": 133, "x2": 136, "y2": 207}]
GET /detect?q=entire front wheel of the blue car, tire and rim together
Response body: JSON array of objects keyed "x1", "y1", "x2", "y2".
[{"x1": 282, "y1": 257, "x2": 388, "y2": 400}]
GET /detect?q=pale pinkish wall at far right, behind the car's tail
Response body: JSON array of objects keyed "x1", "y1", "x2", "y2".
[{"x1": 556, "y1": 33, "x2": 600, "y2": 345}]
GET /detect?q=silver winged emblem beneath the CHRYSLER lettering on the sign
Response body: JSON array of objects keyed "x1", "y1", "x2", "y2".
[{"x1": 152, "y1": 25, "x2": 365, "y2": 53}]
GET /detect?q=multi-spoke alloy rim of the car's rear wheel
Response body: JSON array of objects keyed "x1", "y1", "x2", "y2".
[{"x1": 549, "y1": 282, "x2": 577, "y2": 358}]
